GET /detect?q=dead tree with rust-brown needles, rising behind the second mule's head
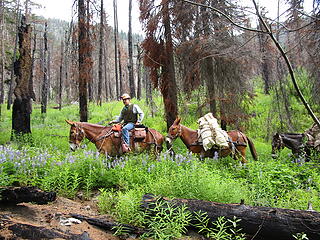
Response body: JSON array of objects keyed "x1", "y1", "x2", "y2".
[{"x1": 140, "y1": 0, "x2": 178, "y2": 129}]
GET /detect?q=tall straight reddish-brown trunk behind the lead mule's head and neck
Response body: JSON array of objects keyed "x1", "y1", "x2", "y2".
[{"x1": 78, "y1": 0, "x2": 90, "y2": 122}]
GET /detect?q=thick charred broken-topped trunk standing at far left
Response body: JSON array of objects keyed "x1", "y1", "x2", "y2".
[{"x1": 11, "y1": 16, "x2": 33, "y2": 139}]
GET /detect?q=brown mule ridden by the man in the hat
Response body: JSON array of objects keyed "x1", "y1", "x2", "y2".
[{"x1": 66, "y1": 120, "x2": 164, "y2": 157}]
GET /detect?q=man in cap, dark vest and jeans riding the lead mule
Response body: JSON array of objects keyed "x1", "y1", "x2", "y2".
[{"x1": 109, "y1": 93, "x2": 144, "y2": 153}]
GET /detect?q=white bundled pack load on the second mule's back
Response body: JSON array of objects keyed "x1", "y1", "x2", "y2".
[{"x1": 197, "y1": 113, "x2": 229, "y2": 151}]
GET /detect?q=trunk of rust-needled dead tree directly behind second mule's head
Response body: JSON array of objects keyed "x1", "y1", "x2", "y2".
[{"x1": 161, "y1": 2, "x2": 178, "y2": 130}]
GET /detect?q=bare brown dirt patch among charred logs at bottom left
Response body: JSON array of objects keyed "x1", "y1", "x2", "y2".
[{"x1": 0, "y1": 197, "x2": 119, "y2": 240}]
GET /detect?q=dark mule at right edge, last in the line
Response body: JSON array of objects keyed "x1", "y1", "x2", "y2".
[{"x1": 271, "y1": 133, "x2": 312, "y2": 161}]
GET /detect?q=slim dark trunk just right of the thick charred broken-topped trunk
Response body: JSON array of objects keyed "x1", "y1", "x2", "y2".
[{"x1": 41, "y1": 23, "x2": 48, "y2": 114}]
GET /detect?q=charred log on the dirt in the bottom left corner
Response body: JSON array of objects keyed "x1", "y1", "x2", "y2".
[{"x1": 0, "y1": 215, "x2": 92, "y2": 240}]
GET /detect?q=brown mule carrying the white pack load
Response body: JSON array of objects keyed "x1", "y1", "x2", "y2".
[{"x1": 166, "y1": 118, "x2": 258, "y2": 163}]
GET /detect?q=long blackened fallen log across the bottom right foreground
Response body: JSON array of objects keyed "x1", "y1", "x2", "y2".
[{"x1": 142, "y1": 194, "x2": 320, "y2": 240}]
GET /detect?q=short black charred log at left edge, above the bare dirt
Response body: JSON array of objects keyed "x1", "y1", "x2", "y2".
[{"x1": 0, "y1": 187, "x2": 57, "y2": 204}]
